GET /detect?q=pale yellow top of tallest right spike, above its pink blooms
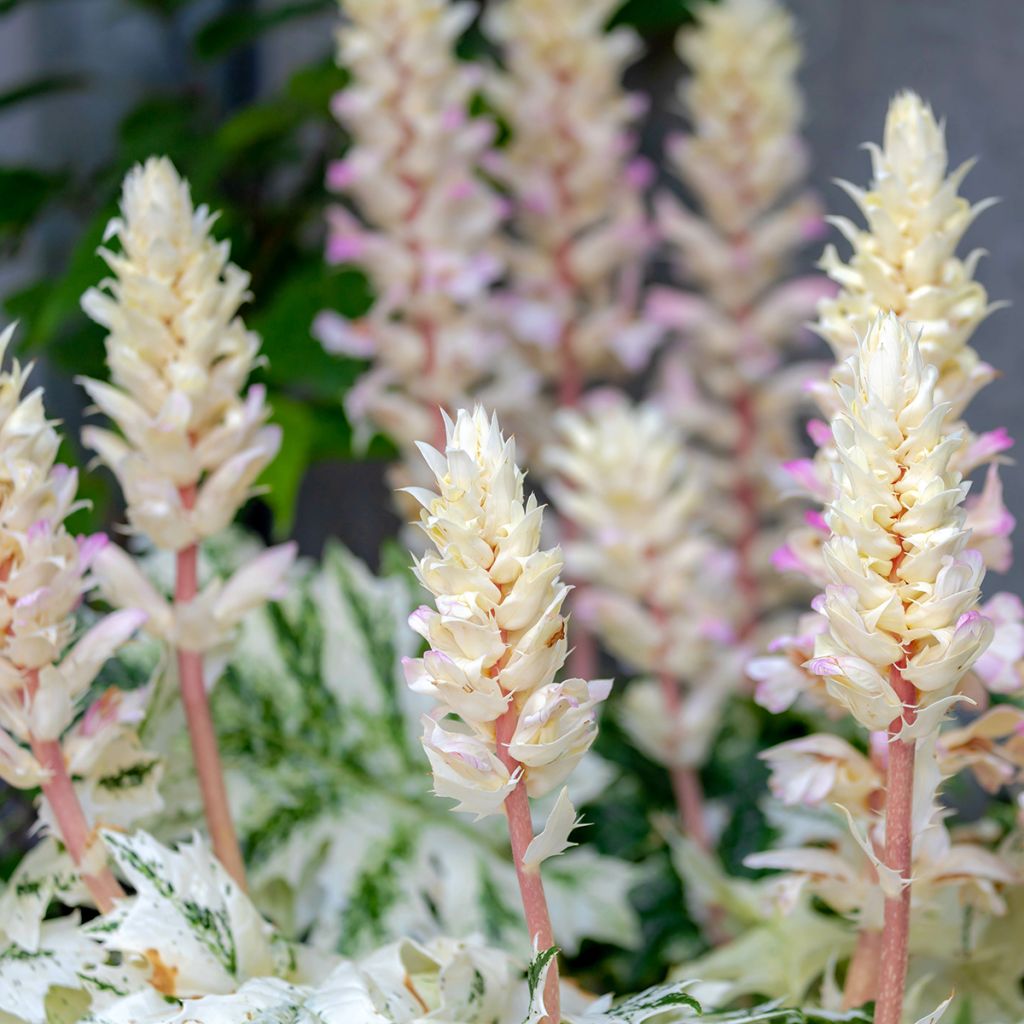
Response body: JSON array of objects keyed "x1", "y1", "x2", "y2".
[{"x1": 817, "y1": 92, "x2": 995, "y2": 416}]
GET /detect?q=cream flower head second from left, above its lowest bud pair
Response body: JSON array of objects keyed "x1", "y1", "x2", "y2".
[{"x1": 82, "y1": 158, "x2": 281, "y2": 551}]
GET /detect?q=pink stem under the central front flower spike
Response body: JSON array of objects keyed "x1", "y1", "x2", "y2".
[{"x1": 495, "y1": 700, "x2": 561, "y2": 1024}]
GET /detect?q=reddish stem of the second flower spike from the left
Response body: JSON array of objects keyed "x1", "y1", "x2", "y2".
[{"x1": 174, "y1": 485, "x2": 248, "y2": 890}]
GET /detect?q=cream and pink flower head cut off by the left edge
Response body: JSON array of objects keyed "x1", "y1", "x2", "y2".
[{"x1": 0, "y1": 328, "x2": 145, "y2": 788}]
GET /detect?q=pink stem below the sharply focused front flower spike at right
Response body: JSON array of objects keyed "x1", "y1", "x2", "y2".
[{"x1": 874, "y1": 667, "x2": 918, "y2": 1024}]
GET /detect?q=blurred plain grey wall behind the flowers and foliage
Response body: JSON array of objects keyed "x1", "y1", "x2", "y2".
[{"x1": 0, "y1": 0, "x2": 1024, "y2": 592}]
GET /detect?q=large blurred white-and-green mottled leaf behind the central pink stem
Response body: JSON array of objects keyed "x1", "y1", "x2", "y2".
[{"x1": 138, "y1": 543, "x2": 640, "y2": 956}]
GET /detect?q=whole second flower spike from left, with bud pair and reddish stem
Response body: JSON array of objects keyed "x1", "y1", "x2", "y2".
[{"x1": 82, "y1": 158, "x2": 295, "y2": 886}]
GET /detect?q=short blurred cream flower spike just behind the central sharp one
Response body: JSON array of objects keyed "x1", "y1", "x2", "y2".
[{"x1": 546, "y1": 391, "x2": 741, "y2": 766}]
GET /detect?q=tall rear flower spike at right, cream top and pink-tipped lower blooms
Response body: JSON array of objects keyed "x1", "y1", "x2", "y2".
[{"x1": 752, "y1": 92, "x2": 1024, "y2": 707}]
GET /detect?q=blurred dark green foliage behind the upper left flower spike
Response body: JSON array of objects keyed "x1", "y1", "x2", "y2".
[{"x1": 0, "y1": 0, "x2": 688, "y2": 549}]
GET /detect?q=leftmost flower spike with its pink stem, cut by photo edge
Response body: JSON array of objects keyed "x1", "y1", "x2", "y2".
[{"x1": 0, "y1": 327, "x2": 145, "y2": 913}]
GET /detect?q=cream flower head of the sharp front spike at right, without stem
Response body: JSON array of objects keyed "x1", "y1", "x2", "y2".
[{"x1": 810, "y1": 313, "x2": 992, "y2": 737}]
